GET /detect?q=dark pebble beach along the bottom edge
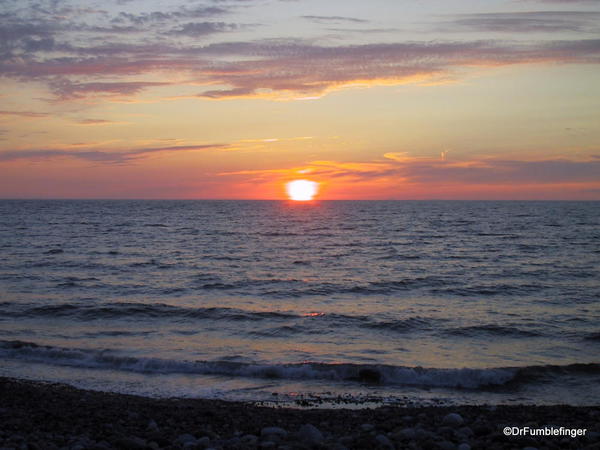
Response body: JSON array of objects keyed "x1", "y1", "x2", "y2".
[{"x1": 0, "y1": 377, "x2": 600, "y2": 450}]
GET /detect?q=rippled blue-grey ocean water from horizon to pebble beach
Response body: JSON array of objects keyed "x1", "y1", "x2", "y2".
[{"x1": 0, "y1": 200, "x2": 600, "y2": 405}]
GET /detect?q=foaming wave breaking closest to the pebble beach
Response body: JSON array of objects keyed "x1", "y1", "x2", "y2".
[{"x1": 0, "y1": 341, "x2": 600, "y2": 389}]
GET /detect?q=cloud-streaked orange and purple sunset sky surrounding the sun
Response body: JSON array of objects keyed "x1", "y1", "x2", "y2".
[{"x1": 0, "y1": 0, "x2": 600, "y2": 200}]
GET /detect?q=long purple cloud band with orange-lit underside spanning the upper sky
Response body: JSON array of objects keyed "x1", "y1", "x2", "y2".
[{"x1": 0, "y1": 39, "x2": 600, "y2": 100}]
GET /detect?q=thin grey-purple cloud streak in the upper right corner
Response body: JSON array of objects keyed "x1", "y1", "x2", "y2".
[{"x1": 438, "y1": 11, "x2": 600, "y2": 33}]
